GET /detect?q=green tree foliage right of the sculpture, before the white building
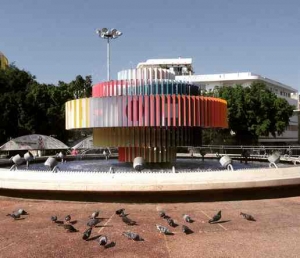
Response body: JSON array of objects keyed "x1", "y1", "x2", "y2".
[{"x1": 217, "y1": 81, "x2": 295, "y2": 144}]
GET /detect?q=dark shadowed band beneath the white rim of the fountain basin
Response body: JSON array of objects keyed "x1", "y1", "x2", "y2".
[{"x1": 0, "y1": 185, "x2": 300, "y2": 203}]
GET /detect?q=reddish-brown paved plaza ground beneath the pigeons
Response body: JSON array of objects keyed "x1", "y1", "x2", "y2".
[{"x1": 0, "y1": 197, "x2": 300, "y2": 258}]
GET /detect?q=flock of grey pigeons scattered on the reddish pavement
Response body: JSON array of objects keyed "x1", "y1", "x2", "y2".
[{"x1": 6, "y1": 208, "x2": 256, "y2": 248}]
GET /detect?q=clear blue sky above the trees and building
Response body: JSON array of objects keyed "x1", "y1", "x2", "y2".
[{"x1": 0, "y1": 0, "x2": 300, "y2": 90}]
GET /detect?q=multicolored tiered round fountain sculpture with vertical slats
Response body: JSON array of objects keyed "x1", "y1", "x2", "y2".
[{"x1": 66, "y1": 68, "x2": 228, "y2": 163}]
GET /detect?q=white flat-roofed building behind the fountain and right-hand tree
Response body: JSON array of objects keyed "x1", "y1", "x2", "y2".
[{"x1": 137, "y1": 58, "x2": 299, "y2": 144}]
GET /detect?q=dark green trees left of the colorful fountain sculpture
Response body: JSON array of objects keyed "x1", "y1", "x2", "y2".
[{"x1": 0, "y1": 65, "x2": 92, "y2": 144}]
